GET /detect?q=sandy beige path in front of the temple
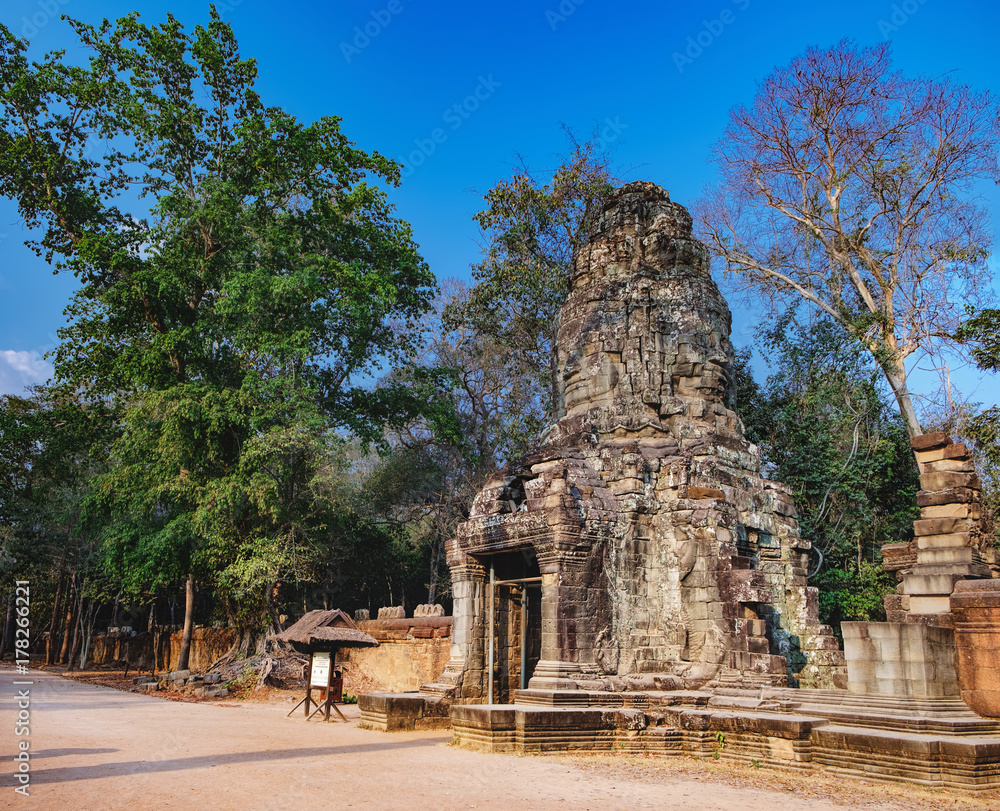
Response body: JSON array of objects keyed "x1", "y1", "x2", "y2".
[{"x1": 0, "y1": 667, "x2": 988, "y2": 811}]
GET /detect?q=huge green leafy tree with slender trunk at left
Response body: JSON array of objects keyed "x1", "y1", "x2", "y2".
[{"x1": 0, "y1": 8, "x2": 433, "y2": 666}]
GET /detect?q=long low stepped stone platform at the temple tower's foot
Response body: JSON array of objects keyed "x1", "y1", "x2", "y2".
[{"x1": 451, "y1": 688, "x2": 1000, "y2": 792}]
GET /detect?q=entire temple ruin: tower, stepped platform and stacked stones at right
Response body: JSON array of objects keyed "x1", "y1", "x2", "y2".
[{"x1": 359, "y1": 183, "x2": 1000, "y2": 791}]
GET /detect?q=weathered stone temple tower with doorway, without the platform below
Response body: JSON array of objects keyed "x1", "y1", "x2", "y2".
[{"x1": 423, "y1": 183, "x2": 846, "y2": 703}]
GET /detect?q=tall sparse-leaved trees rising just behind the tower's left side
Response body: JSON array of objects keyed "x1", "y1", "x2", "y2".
[{"x1": 364, "y1": 141, "x2": 616, "y2": 602}]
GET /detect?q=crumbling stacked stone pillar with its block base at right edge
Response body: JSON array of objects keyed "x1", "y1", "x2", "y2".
[{"x1": 843, "y1": 432, "x2": 1000, "y2": 717}]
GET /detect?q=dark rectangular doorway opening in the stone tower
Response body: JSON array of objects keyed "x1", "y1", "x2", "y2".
[{"x1": 483, "y1": 549, "x2": 542, "y2": 704}]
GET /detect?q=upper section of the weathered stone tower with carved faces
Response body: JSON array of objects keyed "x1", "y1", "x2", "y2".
[{"x1": 557, "y1": 184, "x2": 733, "y2": 427}]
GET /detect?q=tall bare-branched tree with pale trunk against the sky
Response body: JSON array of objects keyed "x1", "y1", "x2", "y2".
[{"x1": 697, "y1": 40, "x2": 1000, "y2": 436}]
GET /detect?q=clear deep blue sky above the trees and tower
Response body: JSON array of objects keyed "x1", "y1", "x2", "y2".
[{"x1": 0, "y1": 0, "x2": 1000, "y2": 412}]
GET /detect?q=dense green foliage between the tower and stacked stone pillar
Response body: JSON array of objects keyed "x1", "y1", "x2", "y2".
[{"x1": 736, "y1": 313, "x2": 918, "y2": 625}]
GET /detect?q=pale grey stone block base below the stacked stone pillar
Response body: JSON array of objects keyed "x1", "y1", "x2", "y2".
[{"x1": 841, "y1": 622, "x2": 958, "y2": 698}]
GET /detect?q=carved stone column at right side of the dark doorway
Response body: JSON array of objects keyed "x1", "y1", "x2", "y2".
[{"x1": 528, "y1": 549, "x2": 594, "y2": 690}]
